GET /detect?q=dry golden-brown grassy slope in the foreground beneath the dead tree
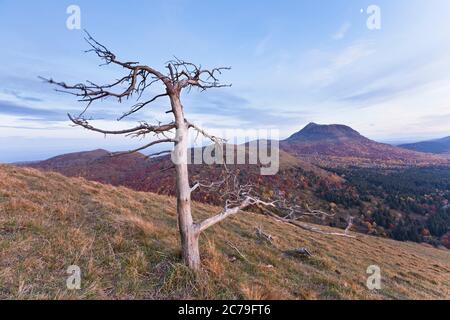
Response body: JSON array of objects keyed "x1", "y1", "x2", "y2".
[{"x1": 0, "y1": 166, "x2": 450, "y2": 299}]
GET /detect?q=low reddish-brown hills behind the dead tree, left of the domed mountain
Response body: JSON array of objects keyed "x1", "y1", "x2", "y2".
[{"x1": 23, "y1": 146, "x2": 342, "y2": 204}]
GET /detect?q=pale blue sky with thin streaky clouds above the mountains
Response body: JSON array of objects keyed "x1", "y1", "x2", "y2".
[{"x1": 0, "y1": 0, "x2": 450, "y2": 162}]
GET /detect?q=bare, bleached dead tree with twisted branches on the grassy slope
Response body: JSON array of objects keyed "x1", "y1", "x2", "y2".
[{"x1": 42, "y1": 32, "x2": 356, "y2": 270}]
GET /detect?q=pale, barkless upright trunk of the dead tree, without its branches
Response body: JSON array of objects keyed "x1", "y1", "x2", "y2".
[{"x1": 170, "y1": 94, "x2": 200, "y2": 270}]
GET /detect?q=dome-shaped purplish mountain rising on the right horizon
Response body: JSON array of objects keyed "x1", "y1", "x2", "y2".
[{"x1": 280, "y1": 123, "x2": 449, "y2": 167}]
